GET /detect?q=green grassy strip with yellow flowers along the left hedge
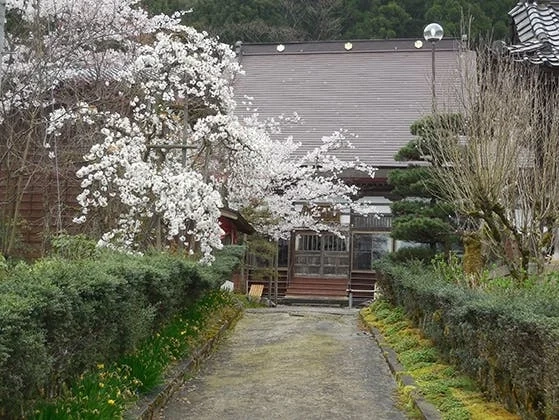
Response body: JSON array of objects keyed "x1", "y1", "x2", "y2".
[{"x1": 33, "y1": 292, "x2": 238, "y2": 420}]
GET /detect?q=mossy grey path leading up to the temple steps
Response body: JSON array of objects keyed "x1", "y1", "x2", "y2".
[{"x1": 160, "y1": 307, "x2": 406, "y2": 420}]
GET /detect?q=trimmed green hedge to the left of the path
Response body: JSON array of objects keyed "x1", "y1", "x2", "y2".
[{"x1": 0, "y1": 249, "x2": 238, "y2": 417}]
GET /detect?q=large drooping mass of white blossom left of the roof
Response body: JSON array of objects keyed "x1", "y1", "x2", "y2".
[{"x1": 5, "y1": 0, "x2": 236, "y2": 261}]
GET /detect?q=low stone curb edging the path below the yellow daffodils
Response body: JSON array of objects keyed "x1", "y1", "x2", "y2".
[{"x1": 124, "y1": 306, "x2": 243, "y2": 420}]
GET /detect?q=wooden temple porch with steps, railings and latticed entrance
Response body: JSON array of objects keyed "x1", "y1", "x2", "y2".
[{"x1": 243, "y1": 215, "x2": 394, "y2": 306}]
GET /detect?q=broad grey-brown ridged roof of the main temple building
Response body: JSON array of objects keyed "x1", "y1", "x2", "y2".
[{"x1": 234, "y1": 39, "x2": 473, "y2": 167}]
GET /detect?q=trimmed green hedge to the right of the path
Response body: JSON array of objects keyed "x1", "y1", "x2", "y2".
[{"x1": 375, "y1": 261, "x2": 559, "y2": 419}]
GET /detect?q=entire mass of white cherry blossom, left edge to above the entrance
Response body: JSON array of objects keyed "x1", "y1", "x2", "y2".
[{"x1": 2, "y1": 0, "x2": 371, "y2": 261}]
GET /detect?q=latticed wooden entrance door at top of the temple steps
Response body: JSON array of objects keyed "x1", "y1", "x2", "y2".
[{"x1": 294, "y1": 232, "x2": 349, "y2": 278}]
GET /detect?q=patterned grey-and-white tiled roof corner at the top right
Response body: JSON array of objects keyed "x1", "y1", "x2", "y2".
[{"x1": 506, "y1": 1, "x2": 559, "y2": 67}]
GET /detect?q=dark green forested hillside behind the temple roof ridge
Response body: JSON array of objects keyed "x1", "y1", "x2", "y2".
[{"x1": 144, "y1": 0, "x2": 517, "y2": 44}]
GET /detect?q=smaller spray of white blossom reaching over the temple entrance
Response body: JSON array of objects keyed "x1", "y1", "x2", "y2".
[{"x1": 227, "y1": 117, "x2": 375, "y2": 240}]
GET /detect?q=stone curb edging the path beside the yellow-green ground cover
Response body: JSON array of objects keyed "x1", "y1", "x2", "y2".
[{"x1": 359, "y1": 312, "x2": 442, "y2": 420}]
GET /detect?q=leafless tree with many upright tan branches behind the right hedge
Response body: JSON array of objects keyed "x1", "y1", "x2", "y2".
[{"x1": 422, "y1": 51, "x2": 559, "y2": 280}]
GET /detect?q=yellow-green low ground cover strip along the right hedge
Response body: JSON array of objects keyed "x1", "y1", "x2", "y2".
[{"x1": 361, "y1": 300, "x2": 520, "y2": 420}]
